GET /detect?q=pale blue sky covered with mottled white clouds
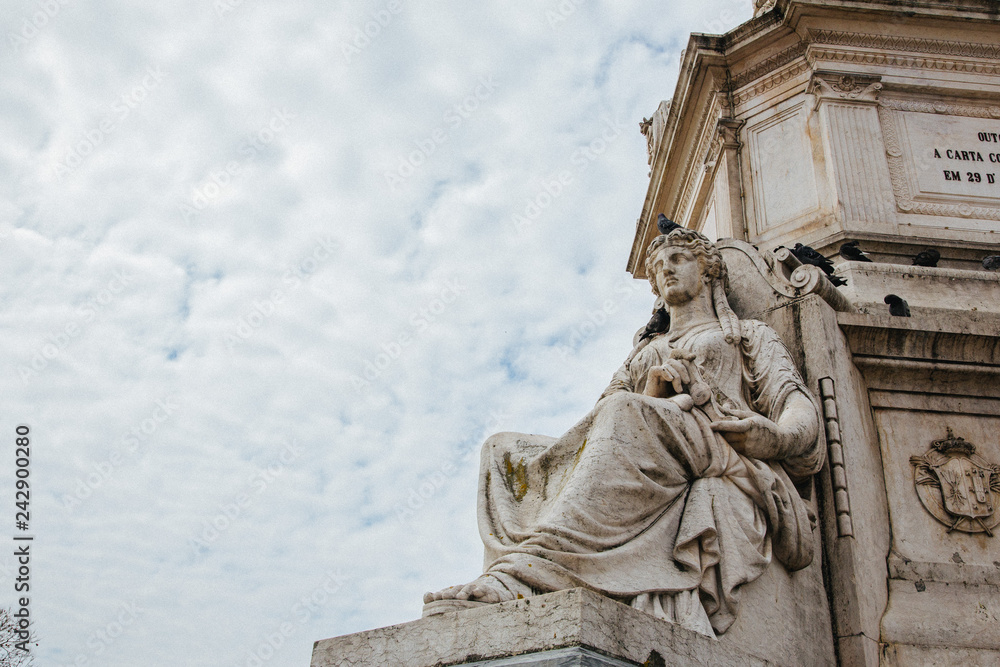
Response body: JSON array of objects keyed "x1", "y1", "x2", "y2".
[{"x1": 0, "y1": 0, "x2": 751, "y2": 667}]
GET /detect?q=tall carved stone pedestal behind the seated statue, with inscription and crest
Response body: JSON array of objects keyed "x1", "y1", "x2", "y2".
[{"x1": 628, "y1": 0, "x2": 1000, "y2": 666}]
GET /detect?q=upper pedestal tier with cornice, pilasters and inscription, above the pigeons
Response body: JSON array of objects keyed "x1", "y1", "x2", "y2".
[{"x1": 629, "y1": 0, "x2": 1000, "y2": 274}]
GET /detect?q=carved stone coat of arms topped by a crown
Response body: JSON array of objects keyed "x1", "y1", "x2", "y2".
[{"x1": 910, "y1": 428, "x2": 1000, "y2": 537}]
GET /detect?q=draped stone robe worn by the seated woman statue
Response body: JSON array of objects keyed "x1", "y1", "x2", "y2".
[{"x1": 479, "y1": 320, "x2": 823, "y2": 635}]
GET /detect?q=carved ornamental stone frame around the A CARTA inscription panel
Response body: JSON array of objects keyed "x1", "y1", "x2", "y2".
[{"x1": 878, "y1": 99, "x2": 1000, "y2": 221}]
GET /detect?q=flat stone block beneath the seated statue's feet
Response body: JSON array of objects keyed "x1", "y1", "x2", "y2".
[{"x1": 311, "y1": 588, "x2": 774, "y2": 667}]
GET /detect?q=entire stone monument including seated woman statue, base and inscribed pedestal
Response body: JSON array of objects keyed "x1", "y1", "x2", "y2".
[{"x1": 312, "y1": 0, "x2": 1000, "y2": 667}]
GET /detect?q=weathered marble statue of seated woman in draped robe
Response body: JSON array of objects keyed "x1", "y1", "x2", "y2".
[{"x1": 424, "y1": 228, "x2": 824, "y2": 636}]
